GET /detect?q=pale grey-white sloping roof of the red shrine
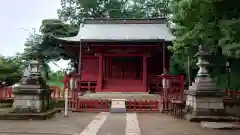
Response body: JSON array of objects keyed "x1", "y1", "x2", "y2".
[{"x1": 57, "y1": 18, "x2": 174, "y2": 42}]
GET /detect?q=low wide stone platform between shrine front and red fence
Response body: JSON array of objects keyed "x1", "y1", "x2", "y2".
[{"x1": 79, "y1": 92, "x2": 161, "y2": 100}]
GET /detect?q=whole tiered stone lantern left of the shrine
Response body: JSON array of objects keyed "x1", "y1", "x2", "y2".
[{"x1": 12, "y1": 50, "x2": 51, "y2": 113}]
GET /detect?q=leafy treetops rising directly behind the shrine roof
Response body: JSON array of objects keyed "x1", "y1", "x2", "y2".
[{"x1": 58, "y1": 0, "x2": 170, "y2": 26}]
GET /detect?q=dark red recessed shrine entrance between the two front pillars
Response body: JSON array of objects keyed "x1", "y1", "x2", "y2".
[{"x1": 103, "y1": 56, "x2": 145, "y2": 92}]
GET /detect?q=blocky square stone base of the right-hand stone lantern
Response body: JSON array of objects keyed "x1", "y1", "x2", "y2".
[{"x1": 185, "y1": 91, "x2": 227, "y2": 121}]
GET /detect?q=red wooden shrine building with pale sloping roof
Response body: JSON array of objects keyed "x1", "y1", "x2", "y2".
[{"x1": 58, "y1": 19, "x2": 180, "y2": 92}]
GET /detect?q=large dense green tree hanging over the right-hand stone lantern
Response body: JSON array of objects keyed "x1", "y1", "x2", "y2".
[{"x1": 170, "y1": 0, "x2": 240, "y2": 88}]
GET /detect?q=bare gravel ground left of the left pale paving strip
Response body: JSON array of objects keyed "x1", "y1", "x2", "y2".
[{"x1": 0, "y1": 113, "x2": 97, "y2": 135}]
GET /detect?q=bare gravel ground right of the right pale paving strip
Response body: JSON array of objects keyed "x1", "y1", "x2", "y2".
[{"x1": 138, "y1": 113, "x2": 240, "y2": 135}]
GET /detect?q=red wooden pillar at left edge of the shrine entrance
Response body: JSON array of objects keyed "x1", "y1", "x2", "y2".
[{"x1": 96, "y1": 54, "x2": 103, "y2": 92}]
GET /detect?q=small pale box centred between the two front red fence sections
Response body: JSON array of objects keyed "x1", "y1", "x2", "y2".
[{"x1": 110, "y1": 99, "x2": 126, "y2": 113}]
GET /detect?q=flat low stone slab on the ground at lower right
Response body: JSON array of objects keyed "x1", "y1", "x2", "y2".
[{"x1": 201, "y1": 122, "x2": 240, "y2": 130}]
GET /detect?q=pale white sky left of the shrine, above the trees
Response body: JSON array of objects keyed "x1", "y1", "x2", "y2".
[{"x1": 0, "y1": 0, "x2": 67, "y2": 70}]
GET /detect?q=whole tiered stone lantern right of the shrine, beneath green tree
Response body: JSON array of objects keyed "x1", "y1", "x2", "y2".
[{"x1": 185, "y1": 45, "x2": 226, "y2": 121}]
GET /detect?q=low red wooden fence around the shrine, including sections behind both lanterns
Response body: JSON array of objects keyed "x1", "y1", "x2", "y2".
[{"x1": 0, "y1": 79, "x2": 240, "y2": 112}]
